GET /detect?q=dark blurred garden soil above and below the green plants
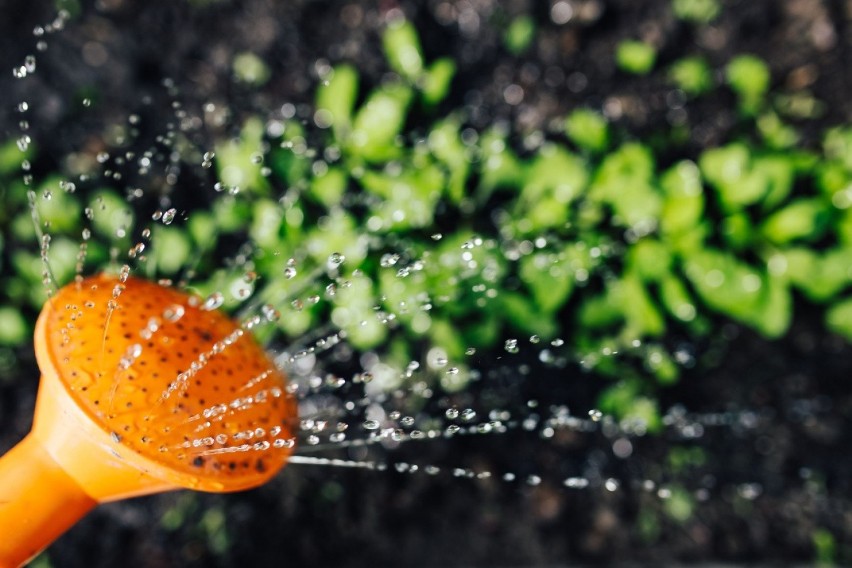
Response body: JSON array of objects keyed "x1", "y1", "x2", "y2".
[{"x1": 0, "y1": 0, "x2": 852, "y2": 568}]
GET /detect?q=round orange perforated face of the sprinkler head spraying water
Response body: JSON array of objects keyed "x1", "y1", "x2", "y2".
[{"x1": 35, "y1": 275, "x2": 297, "y2": 491}]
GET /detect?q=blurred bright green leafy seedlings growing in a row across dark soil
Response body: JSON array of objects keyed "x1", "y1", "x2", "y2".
[{"x1": 0, "y1": 8, "x2": 852, "y2": 432}]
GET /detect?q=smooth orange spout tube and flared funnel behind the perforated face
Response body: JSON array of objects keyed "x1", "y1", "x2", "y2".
[{"x1": 0, "y1": 366, "x2": 177, "y2": 568}]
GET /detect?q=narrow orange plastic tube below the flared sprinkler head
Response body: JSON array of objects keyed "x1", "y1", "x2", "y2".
[{"x1": 0, "y1": 433, "x2": 97, "y2": 568}]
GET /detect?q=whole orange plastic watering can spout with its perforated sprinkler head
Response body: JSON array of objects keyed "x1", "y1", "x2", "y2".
[{"x1": 0, "y1": 275, "x2": 297, "y2": 568}]
